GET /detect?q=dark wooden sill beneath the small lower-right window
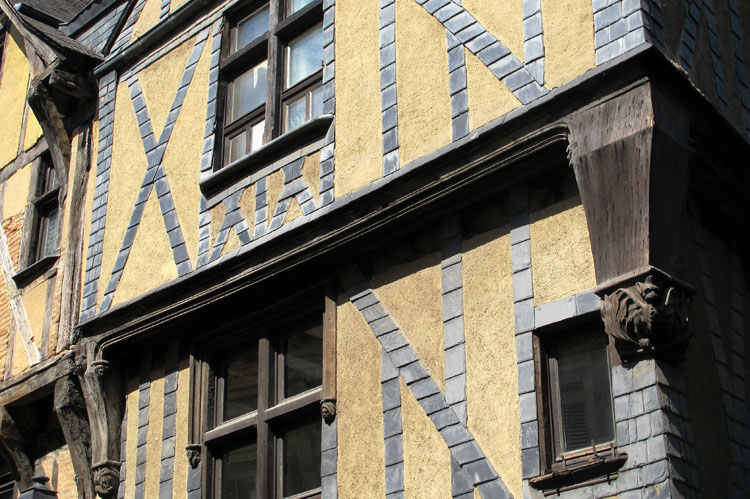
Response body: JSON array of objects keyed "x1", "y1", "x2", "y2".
[{"x1": 529, "y1": 452, "x2": 628, "y2": 495}]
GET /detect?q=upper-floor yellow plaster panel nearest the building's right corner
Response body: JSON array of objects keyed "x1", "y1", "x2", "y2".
[{"x1": 544, "y1": 0, "x2": 596, "y2": 89}]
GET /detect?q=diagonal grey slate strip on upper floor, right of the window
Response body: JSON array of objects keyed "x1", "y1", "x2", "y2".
[{"x1": 414, "y1": 0, "x2": 548, "y2": 104}]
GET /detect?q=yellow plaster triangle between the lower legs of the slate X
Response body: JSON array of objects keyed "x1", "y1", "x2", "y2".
[{"x1": 111, "y1": 195, "x2": 177, "y2": 306}]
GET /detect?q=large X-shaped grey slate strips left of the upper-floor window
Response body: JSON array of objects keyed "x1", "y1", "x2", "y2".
[{"x1": 100, "y1": 29, "x2": 209, "y2": 313}]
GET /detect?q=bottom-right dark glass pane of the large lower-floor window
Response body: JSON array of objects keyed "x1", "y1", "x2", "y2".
[{"x1": 281, "y1": 418, "x2": 320, "y2": 497}]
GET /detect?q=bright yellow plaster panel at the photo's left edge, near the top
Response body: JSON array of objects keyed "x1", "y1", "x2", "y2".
[{"x1": 0, "y1": 27, "x2": 29, "y2": 166}]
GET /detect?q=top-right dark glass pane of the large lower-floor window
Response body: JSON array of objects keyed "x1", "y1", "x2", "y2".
[{"x1": 284, "y1": 325, "x2": 323, "y2": 397}]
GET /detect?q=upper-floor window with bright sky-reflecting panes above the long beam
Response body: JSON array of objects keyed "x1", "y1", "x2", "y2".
[{"x1": 217, "y1": 0, "x2": 323, "y2": 167}]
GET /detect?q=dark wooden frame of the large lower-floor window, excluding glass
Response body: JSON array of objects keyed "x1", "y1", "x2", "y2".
[{"x1": 190, "y1": 286, "x2": 336, "y2": 499}]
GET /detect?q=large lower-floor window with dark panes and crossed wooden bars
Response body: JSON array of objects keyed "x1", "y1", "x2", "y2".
[{"x1": 203, "y1": 313, "x2": 323, "y2": 499}]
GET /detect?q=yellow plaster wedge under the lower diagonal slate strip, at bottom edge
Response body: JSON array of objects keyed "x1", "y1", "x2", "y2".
[{"x1": 399, "y1": 379, "x2": 451, "y2": 499}]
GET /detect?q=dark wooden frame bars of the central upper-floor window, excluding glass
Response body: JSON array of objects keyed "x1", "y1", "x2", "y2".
[{"x1": 214, "y1": 0, "x2": 323, "y2": 171}]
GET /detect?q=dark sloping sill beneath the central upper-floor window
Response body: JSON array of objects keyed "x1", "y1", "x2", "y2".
[{"x1": 200, "y1": 114, "x2": 333, "y2": 197}]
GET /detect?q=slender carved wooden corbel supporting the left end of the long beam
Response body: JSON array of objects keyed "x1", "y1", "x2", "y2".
[{"x1": 79, "y1": 341, "x2": 122, "y2": 499}]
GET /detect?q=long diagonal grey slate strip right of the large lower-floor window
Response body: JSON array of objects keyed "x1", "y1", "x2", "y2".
[{"x1": 339, "y1": 265, "x2": 513, "y2": 499}]
